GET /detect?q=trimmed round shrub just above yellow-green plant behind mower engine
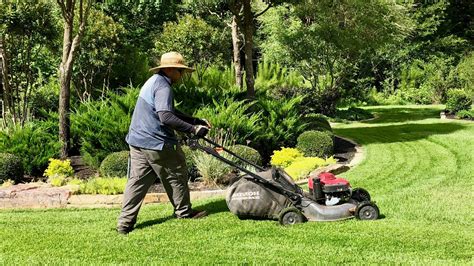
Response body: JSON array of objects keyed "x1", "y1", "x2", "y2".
[{"x1": 296, "y1": 130, "x2": 334, "y2": 158}]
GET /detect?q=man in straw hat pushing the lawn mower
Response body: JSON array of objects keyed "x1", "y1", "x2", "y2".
[{"x1": 117, "y1": 52, "x2": 210, "y2": 234}]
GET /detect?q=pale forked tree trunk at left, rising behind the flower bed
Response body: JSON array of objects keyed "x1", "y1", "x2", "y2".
[{"x1": 57, "y1": 0, "x2": 93, "y2": 158}]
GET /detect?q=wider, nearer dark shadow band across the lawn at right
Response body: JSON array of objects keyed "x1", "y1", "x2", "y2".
[{"x1": 337, "y1": 123, "x2": 466, "y2": 145}]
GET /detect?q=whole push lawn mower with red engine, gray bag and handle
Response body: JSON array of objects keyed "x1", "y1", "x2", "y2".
[{"x1": 187, "y1": 137, "x2": 379, "y2": 225}]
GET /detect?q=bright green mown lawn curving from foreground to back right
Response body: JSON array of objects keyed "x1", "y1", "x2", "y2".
[{"x1": 0, "y1": 106, "x2": 474, "y2": 265}]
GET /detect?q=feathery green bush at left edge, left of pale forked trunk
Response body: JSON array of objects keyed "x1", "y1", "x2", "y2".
[{"x1": 0, "y1": 120, "x2": 61, "y2": 176}]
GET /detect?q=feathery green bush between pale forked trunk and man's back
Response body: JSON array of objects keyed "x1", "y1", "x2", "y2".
[{"x1": 71, "y1": 88, "x2": 139, "y2": 168}]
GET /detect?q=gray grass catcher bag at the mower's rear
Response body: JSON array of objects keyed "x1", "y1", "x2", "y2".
[{"x1": 226, "y1": 170, "x2": 291, "y2": 219}]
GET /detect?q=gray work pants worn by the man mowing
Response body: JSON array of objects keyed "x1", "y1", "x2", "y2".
[{"x1": 117, "y1": 145, "x2": 191, "y2": 229}]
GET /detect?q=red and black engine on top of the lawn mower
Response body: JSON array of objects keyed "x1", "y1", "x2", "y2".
[{"x1": 308, "y1": 172, "x2": 370, "y2": 206}]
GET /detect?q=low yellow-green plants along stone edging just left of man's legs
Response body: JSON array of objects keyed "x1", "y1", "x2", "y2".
[{"x1": 72, "y1": 177, "x2": 127, "y2": 195}]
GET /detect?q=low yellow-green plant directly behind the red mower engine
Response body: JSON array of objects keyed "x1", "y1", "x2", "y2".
[{"x1": 285, "y1": 157, "x2": 336, "y2": 180}]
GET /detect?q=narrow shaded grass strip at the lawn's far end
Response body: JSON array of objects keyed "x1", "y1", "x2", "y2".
[{"x1": 364, "y1": 107, "x2": 441, "y2": 124}]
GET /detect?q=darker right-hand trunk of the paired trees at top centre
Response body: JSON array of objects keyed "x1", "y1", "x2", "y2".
[{"x1": 243, "y1": 0, "x2": 255, "y2": 99}]
